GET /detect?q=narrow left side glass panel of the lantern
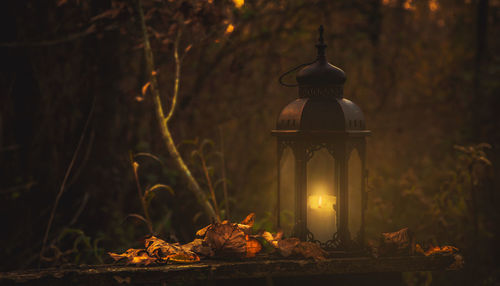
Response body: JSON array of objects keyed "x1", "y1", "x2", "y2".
[{"x1": 279, "y1": 147, "x2": 295, "y2": 237}]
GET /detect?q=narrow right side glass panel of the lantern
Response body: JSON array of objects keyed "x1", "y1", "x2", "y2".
[{"x1": 348, "y1": 149, "x2": 362, "y2": 239}]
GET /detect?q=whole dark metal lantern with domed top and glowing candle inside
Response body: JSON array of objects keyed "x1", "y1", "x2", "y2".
[{"x1": 272, "y1": 26, "x2": 370, "y2": 251}]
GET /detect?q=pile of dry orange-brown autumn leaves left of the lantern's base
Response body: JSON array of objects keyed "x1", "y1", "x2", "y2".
[{"x1": 109, "y1": 213, "x2": 327, "y2": 265}]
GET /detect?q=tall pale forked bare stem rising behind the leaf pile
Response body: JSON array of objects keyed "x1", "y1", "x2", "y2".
[{"x1": 137, "y1": 0, "x2": 219, "y2": 221}]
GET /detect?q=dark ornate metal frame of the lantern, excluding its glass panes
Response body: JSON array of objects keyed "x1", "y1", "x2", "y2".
[{"x1": 272, "y1": 27, "x2": 371, "y2": 250}]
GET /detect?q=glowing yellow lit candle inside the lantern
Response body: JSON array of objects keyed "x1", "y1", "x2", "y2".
[{"x1": 307, "y1": 194, "x2": 337, "y2": 242}]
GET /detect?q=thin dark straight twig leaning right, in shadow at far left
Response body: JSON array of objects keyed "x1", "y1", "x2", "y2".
[{"x1": 39, "y1": 97, "x2": 96, "y2": 260}]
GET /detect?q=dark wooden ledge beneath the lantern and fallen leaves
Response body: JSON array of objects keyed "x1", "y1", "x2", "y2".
[{"x1": 0, "y1": 255, "x2": 460, "y2": 286}]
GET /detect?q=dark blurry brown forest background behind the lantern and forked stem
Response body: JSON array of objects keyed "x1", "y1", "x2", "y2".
[{"x1": 0, "y1": 0, "x2": 500, "y2": 285}]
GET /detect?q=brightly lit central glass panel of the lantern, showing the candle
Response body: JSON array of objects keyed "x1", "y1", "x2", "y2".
[{"x1": 307, "y1": 148, "x2": 337, "y2": 242}]
